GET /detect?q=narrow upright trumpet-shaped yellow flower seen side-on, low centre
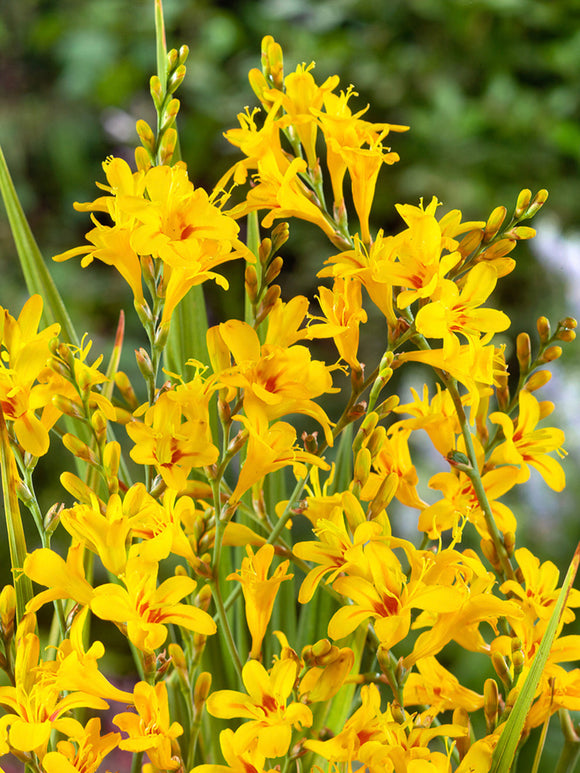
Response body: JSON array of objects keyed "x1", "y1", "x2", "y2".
[{"x1": 226, "y1": 544, "x2": 294, "y2": 659}]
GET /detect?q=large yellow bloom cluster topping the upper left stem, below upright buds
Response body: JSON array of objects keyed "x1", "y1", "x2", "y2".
[{"x1": 54, "y1": 158, "x2": 253, "y2": 325}]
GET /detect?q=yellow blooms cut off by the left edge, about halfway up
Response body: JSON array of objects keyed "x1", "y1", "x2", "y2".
[{"x1": 0, "y1": 295, "x2": 60, "y2": 456}]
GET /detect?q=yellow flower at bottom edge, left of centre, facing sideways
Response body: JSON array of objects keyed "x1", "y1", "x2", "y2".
[{"x1": 113, "y1": 682, "x2": 183, "y2": 770}]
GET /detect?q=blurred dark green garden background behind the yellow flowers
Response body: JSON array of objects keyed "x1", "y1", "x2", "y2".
[{"x1": 0, "y1": 0, "x2": 580, "y2": 770}]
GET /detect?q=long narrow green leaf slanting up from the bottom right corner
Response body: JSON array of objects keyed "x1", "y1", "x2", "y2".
[{"x1": 490, "y1": 544, "x2": 580, "y2": 773}]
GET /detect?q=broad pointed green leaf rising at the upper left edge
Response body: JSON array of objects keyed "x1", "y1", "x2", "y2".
[{"x1": 0, "y1": 142, "x2": 79, "y2": 346}]
